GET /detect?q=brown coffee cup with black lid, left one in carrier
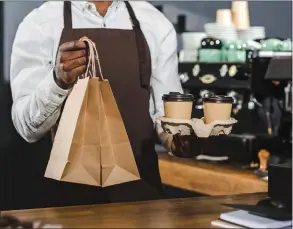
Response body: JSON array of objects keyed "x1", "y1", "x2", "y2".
[{"x1": 162, "y1": 92, "x2": 194, "y2": 119}]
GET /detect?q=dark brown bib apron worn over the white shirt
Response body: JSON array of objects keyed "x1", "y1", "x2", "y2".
[{"x1": 45, "y1": 1, "x2": 161, "y2": 206}]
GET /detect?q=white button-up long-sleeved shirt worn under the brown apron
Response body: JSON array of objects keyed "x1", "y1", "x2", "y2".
[{"x1": 10, "y1": 1, "x2": 182, "y2": 142}]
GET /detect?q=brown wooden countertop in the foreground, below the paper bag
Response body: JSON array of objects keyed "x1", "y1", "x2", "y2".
[{"x1": 2, "y1": 193, "x2": 266, "y2": 228}]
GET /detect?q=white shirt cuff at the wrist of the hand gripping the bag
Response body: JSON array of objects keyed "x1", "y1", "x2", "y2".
[{"x1": 37, "y1": 69, "x2": 69, "y2": 105}]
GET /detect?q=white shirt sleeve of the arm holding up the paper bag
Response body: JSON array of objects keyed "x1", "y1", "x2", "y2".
[{"x1": 10, "y1": 21, "x2": 68, "y2": 142}]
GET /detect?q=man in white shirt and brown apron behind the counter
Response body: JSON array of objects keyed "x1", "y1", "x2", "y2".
[{"x1": 11, "y1": 1, "x2": 182, "y2": 207}]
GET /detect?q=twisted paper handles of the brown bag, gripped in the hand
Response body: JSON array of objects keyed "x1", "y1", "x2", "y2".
[{"x1": 80, "y1": 37, "x2": 104, "y2": 80}]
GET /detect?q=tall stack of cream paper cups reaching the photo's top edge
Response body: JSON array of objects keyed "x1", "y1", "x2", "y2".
[{"x1": 232, "y1": 1, "x2": 250, "y2": 30}]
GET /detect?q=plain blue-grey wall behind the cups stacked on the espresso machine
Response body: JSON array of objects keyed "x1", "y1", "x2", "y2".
[{"x1": 152, "y1": 1, "x2": 292, "y2": 37}]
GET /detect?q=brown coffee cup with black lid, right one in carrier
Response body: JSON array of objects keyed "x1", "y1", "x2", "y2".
[{"x1": 203, "y1": 96, "x2": 233, "y2": 124}]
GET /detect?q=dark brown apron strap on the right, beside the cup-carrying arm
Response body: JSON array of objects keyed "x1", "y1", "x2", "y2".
[{"x1": 125, "y1": 1, "x2": 151, "y2": 89}]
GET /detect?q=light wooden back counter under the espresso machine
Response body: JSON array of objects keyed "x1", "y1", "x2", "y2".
[{"x1": 159, "y1": 153, "x2": 268, "y2": 195}]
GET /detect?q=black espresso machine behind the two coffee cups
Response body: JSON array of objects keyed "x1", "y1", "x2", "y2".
[{"x1": 179, "y1": 50, "x2": 292, "y2": 165}]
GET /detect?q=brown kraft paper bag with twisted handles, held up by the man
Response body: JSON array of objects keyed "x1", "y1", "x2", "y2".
[{"x1": 45, "y1": 39, "x2": 140, "y2": 187}]
